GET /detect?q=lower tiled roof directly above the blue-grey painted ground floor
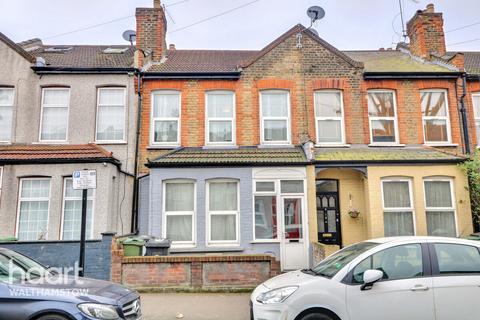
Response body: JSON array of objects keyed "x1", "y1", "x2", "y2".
[{"x1": 147, "y1": 147, "x2": 308, "y2": 167}]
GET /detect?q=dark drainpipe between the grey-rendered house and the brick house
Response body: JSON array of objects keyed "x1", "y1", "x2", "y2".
[{"x1": 131, "y1": 69, "x2": 143, "y2": 234}]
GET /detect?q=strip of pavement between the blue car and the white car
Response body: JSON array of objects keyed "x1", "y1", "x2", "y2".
[{"x1": 141, "y1": 293, "x2": 250, "y2": 320}]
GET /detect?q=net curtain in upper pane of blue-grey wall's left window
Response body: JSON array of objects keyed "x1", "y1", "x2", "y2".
[{"x1": 165, "y1": 182, "x2": 194, "y2": 211}]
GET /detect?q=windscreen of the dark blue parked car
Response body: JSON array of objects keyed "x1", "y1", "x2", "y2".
[{"x1": 0, "y1": 250, "x2": 47, "y2": 283}]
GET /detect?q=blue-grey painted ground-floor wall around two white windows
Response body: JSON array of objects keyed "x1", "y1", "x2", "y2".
[{"x1": 144, "y1": 167, "x2": 280, "y2": 258}]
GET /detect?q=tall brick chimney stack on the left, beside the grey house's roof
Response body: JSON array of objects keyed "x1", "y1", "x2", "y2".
[{"x1": 135, "y1": 0, "x2": 167, "y2": 67}]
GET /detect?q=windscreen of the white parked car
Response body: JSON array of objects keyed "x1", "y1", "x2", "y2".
[{"x1": 311, "y1": 242, "x2": 379, "y2": 278}]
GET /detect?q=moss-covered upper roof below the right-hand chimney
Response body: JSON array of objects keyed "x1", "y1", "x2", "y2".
[{"x1": 344, "y1": 50, "x2": 456, "y2": 72}]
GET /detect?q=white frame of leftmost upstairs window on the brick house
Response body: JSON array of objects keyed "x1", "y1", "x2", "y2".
[{"x1": 150, "y1": 90, "x2": 182, "y2": 147}]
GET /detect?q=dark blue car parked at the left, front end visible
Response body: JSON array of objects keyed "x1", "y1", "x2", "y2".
[{"x1": 0, "y1": 248, "x2": 142, "y2": 320}]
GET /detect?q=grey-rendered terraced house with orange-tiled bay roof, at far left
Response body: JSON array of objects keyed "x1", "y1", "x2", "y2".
[{"x1": 0, "y1": 34, "x2": 137, "y2": 241}]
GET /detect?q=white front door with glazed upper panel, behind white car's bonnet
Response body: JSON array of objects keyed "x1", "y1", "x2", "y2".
[{"x1": 280, "y1": 196, "x2": 308, "y2": 270}]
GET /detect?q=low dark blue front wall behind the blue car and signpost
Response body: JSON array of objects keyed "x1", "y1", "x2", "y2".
[{"x1": 0, "y1": 233, "x2": 114, "y2": 280}]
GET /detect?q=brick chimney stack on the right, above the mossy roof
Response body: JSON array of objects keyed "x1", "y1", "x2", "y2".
[{"x1": 407, "y1": 4, "x2": 447, "y2": 60}]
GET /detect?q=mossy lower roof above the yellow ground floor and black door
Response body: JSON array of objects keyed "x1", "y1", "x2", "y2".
[{"x1": 315, "y1": 147, "x2": 466, "y2": 164}]
